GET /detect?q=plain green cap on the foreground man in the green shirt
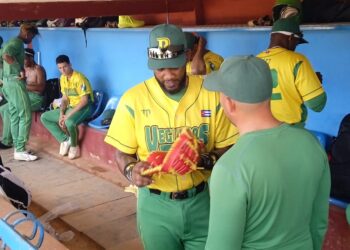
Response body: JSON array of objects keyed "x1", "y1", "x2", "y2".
[{"x1": 204, "y1": 55, "x2": 272, "y2": 103}]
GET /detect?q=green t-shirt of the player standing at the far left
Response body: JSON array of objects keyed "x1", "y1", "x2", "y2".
[{"x1": 2, "y1": 37, "x2": 24, "y2": 77}]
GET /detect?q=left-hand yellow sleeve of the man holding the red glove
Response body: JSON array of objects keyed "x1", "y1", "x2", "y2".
[{"x1": 105, "y1": 93, "x2": 138, "y2": 154}]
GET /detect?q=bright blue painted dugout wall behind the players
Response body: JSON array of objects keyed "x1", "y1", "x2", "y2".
[{"x1": 0, "y1": 25, "x2": 350, "y2": 135}]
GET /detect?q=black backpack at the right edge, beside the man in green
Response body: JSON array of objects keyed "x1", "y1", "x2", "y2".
[{"x1": 330, "y1": 114, "x2": 350, "y2": 202}]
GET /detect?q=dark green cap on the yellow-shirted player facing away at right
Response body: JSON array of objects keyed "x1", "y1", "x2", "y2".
[{"x1": 271, "y1": 17, "x2": 308, "y2": 44}]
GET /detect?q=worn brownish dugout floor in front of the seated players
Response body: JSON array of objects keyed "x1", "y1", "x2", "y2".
[{"x1": 0, "y1": 137, "x2": 142, "y2": 250}]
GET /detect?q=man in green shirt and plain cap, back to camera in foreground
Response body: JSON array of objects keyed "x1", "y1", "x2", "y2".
[{"x1": 204, "y1": 56, "x2": 330, "y2": 250}]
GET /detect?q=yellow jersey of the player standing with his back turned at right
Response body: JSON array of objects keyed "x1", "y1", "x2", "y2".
[{"x1": 257, "y1": 47, "x2": 324, "y2": 124}]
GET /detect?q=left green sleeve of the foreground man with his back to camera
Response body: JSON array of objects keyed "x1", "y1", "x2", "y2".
[{"x1": 205, "y1": 162, "x2": 247, "y2": 250}]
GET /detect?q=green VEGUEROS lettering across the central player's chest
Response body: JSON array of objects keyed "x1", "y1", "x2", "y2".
[{"x1": 145, "y1": 123, "x2": 209, "y2": 152}]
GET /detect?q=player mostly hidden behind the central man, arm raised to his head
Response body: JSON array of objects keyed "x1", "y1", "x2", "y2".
[{"x1": 185, "y1": 32, "x2": 224, "y2": 75}]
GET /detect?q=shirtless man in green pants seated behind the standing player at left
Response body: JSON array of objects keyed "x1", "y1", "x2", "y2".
[{"x1": 0, "y1": 48, "x2": 46, "y2": 149}]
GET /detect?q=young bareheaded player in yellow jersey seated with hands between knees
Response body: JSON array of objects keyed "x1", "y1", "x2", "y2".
[{"x1": 41, "y1": 55, "x2": 94, "y2": 160}]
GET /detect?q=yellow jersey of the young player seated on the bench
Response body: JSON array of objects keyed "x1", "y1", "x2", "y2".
[{"x1": 60, "y1": 71, "x2": 94, "y2": 108}]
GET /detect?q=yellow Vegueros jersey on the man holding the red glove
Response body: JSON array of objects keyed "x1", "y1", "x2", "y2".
[{"x1": 105, "y1": 76, "x2": 238, "y2": 192}]
